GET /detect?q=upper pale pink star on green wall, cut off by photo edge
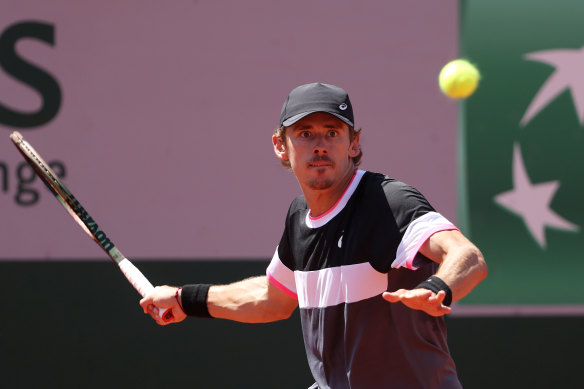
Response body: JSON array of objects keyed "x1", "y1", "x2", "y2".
[{"x1": 520, "y1": 47, "x2": 584, "y2": 127}]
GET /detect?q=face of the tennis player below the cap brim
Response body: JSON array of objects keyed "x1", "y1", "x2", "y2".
[{"x1": 274, "y1": 112, "x2": 359, "y2": 190}]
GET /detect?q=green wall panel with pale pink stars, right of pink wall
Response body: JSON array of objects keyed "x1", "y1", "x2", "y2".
[{"x1": 457, "y1": 0, "x2": 584, "y2": 306}]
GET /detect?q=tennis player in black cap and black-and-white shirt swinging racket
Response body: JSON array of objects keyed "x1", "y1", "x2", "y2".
[{"x1": 140, "y1": 83, "x2": 487, "y2": 389}]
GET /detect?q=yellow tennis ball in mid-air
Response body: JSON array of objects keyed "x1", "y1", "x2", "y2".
[{"x1": 438, "y1": 59, "x2": 481, "y2": 99}]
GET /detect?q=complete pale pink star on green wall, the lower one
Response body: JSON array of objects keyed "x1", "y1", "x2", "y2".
[{"x1": 495, "y1": 144, "x2": 579, "y2": 248}]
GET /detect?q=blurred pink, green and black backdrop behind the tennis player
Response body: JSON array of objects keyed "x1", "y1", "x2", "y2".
[{"x1": 0, "y1": 0, "x2": 584, "y2": 388}]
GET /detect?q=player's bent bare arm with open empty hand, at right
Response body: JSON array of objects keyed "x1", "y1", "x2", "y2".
[{"x1": 383, "y1": 230, "x2": 487, "y2": 316}]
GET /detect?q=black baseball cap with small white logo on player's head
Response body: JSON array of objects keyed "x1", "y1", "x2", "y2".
[{"x1": 280, "y1": 82, "x2": 355, "y2": 127}]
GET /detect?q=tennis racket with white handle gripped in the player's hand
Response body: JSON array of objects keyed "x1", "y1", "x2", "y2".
[{"x1": 10, "y1": 131, "x2": 173, "y2": 322}]
